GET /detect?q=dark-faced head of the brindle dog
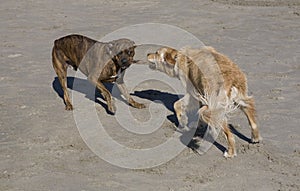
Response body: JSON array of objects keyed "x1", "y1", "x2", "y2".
[{"x1": 108, "y1": 39, "x2": 136, "y2": 70}]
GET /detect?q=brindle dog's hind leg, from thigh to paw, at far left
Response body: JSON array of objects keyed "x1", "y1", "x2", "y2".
[{"x1": 52, "y1": 48, "x2": 73, "y2": 110}]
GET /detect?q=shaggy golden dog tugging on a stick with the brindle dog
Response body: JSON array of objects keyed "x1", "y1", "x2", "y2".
[{"x1": 147, "y1": 47, "x2": 261, "y2": 158}]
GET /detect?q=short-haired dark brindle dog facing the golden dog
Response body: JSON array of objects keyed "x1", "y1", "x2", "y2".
[{"x1": 52, "y1": 34, "x2": 145, "y2": 114}]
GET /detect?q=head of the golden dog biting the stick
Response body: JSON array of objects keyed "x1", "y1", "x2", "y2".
[{"x1": 147, "y1": 47, "x2": 178, "y2": 77}]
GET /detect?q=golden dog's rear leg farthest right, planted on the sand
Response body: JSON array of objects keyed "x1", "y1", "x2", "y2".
[{"x1": 241, "y1": 97, "x2": 262, "y2": 143}]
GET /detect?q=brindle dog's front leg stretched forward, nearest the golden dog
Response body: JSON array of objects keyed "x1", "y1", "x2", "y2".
[{"x1": 116, "y1": 71, "x2": 146, "y2": 109}]
